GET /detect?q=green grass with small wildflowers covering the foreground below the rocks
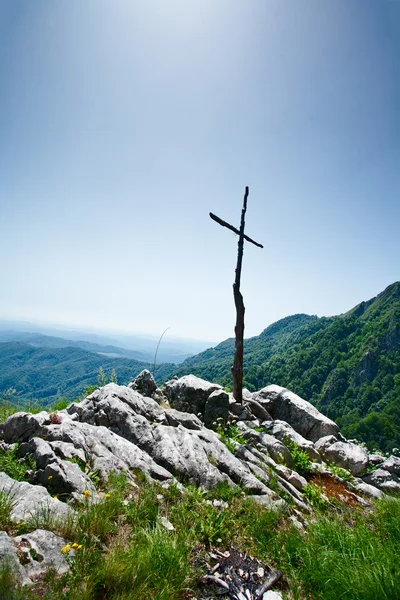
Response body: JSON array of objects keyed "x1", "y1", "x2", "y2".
[{"x1": 0, "y1": 474, "x2": 400, "y2": 600}]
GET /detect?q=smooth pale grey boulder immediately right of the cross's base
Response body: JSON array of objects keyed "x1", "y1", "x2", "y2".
[{"x1": 253, "y1": 385, "x2": 339, "y2": 442}]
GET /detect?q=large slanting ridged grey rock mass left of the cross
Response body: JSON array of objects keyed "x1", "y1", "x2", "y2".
[{"x1": 4, "y1": 383, "x2": 268, "y2": 495}]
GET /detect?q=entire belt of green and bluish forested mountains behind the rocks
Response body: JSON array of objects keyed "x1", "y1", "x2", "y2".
[{"x1": 0, "y1": 282, "x2": 400, "y2": 450}]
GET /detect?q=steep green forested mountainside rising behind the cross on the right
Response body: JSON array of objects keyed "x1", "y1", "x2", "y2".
[{"x1": 177, "y1": 282, "x2": 400, "y2": 449}]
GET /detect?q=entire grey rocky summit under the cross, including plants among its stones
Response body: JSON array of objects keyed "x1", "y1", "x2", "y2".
[{"x1": 0, "y1": 371, "x2": 400, "y2": 598}]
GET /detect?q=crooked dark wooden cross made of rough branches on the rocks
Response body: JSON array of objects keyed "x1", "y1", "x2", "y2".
[{"x1": 210, "y1": 186, "x2": 264, "y2": 404}]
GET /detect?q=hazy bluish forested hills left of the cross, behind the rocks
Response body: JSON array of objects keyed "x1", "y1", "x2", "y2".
[{"x1": 0, "y1": 342, "x2": 175, "y2": 404}]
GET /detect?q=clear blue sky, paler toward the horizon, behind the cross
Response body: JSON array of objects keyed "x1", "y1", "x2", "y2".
[{"x1": 0, "y1": 0, "x2": 400, "y2": 342}]
